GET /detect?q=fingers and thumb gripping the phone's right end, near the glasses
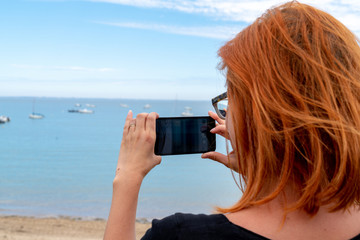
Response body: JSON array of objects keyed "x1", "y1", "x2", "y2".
[{"x1": 201, "y1": 111, "x2": 239, "y2": 172}]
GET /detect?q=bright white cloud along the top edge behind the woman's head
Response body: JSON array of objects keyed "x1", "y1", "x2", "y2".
[{"x1": 88, "y1": 0, "x2": 360, "y2": 35}]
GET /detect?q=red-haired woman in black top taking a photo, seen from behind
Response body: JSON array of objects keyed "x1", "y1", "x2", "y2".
[{"x1": 105, "y1": 2, "x2": 360, "y2": 239}]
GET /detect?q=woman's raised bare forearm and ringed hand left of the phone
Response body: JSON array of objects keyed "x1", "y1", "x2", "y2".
[{"x1": 104, "y1": 111, "x2": 161, "y2": 240}]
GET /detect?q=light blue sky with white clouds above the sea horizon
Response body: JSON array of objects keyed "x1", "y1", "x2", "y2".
[{"x1": 0, "y1": 0, "x2": 360, "y2": 100}]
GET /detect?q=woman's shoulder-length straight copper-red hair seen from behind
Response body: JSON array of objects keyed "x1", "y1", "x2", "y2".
[{"x1": 219, "y1": 2, "x2": 360, "y2": 215}]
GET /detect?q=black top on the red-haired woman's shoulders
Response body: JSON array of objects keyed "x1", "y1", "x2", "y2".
[{"x1": 142, "y1": 213, "x2": 360, "y2": 240}]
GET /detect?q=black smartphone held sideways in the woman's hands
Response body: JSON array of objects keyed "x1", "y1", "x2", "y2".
[{"x1": 155, "y1": 116, "x2": 216, "y2": 155}]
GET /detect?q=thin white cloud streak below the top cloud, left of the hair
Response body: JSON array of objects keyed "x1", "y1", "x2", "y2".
[{"x1": 99, "y1": 22, "x2": 242, "y2": 40}]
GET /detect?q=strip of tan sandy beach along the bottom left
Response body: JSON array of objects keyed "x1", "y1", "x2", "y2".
[{"x1": 0, "y1": 216, "x2": 151, "y2": 240}]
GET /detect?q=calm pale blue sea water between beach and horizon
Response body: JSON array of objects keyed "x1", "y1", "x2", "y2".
[{"x1": 0, "y1": 97, "x2": 241, "y2": 219}]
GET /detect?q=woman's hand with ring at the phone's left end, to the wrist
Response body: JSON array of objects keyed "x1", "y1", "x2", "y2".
[{"x1": 116, "y1": 110, "x2": 161, "y2": 178}]
